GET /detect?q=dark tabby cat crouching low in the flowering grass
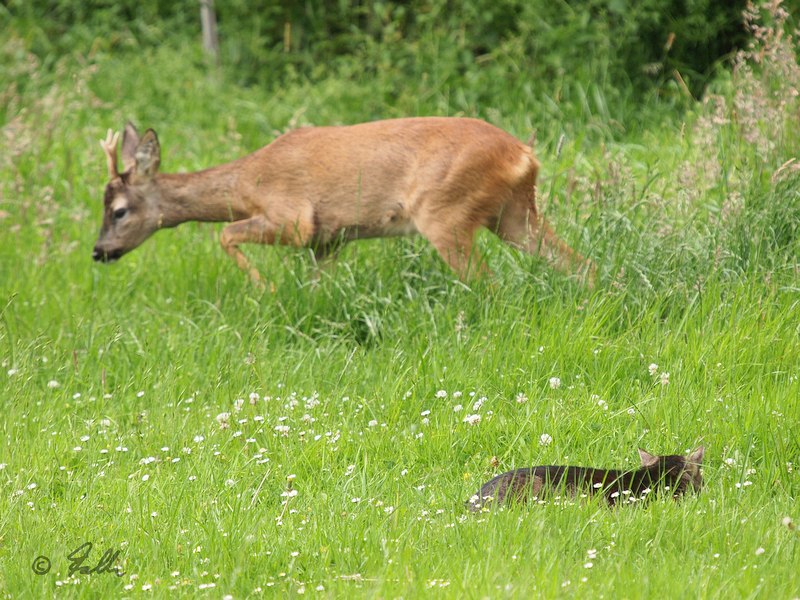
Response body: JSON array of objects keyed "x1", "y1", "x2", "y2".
[{"x1": 467, "y1": 446, "x2": 704, "y2": 511}]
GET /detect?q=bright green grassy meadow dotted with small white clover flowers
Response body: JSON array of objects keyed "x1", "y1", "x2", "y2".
[{"x1": 0, "y1": 2, "x2": 800, "y2": 599}]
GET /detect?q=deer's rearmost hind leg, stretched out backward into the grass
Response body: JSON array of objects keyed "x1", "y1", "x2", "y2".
[{"x1": 492, "y1": 196, "x2": 595, "y2": 288}]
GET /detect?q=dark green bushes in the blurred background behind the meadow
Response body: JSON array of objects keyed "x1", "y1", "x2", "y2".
[{"x1": 3, "y1": 0, "x2": 756, "y2": 96}]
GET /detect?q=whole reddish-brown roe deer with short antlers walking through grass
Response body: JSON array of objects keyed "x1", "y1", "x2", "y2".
[{"x1": 92, "y1": 117, "x2": 594, "y2": 285}]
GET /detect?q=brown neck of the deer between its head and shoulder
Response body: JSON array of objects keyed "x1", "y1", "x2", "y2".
[{"x1": 155, "y1": 165, "x2": 247, "y2": 227}]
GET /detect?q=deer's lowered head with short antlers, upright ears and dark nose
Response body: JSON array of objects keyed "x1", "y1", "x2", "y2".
[{"x1": 92, "y1": 123, "x2": 161, "y2": 262}]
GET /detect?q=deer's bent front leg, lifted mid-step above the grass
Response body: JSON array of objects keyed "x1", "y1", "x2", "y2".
[{"x1": 219, "y1": 215, "x2": 313, "y2": 287}]
